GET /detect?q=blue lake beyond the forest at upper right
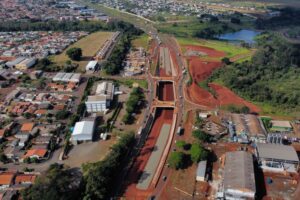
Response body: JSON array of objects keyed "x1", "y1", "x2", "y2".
[{"x1": 217, "y1": 29, "x2": 260, "y2": 44}]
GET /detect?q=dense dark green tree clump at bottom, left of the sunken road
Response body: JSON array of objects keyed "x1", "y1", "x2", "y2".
[{"x1": 82, "y1": 133, "x2": 135, "y2": 200}]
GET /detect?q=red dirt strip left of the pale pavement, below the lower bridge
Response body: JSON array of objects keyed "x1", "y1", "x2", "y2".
[{"x1": 125, "y1": 108, "x2": 173, "y2": 200}]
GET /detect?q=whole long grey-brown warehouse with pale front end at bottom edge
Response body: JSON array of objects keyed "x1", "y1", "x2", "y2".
[{"x1": 223, "y1": 151, "x2": 256, "y2": 200}]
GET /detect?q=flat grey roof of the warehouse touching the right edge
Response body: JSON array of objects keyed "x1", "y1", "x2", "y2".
[{"x1": 257, "y1": 143, "x2": 299, "y2": 162}]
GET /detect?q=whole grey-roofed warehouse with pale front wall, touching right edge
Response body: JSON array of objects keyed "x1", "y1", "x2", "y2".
[{"x1": 255, "y1": 143, "x2": 299, "y2": 172}]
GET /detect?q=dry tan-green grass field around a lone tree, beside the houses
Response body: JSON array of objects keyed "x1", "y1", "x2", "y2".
[{"x1": 50, "y1": 32, "x2": 113, "y2": 70}]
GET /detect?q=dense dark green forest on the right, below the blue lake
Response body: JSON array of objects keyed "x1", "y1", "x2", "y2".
[{"x1": 209, "y1": 34, "x2": 300, "y2": 108}]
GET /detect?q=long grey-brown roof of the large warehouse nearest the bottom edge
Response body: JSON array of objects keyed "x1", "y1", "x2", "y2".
[{"x1": 224, "y1": 151, "x2": 255, "y2": 192}]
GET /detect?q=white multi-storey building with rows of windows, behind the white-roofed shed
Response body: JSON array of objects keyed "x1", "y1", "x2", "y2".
[{"x1": 85, "y1": 82, "x2": 114, "y2": 113}]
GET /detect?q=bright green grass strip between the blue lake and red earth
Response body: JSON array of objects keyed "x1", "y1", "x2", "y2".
[{"x1": 177, "y1": 37, "x2": 250, "y2": 58}]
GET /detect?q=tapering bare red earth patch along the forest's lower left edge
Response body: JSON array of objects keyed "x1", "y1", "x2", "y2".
[{"x1": 209, "y1": 83, "x2": 260, "y2": 113}]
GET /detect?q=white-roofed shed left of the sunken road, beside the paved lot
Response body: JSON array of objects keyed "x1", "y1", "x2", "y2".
[{"x1": 71, "y1": 120, "x2": 95, "y2": 144}]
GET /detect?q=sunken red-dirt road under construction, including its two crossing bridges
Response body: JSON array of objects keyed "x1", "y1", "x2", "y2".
[{"x1": 125, "y1": 33, "x2": 183, "y2": 199}]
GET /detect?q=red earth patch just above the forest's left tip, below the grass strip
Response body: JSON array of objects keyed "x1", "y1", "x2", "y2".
[{"x1": 189, "y1": 58, "x2": 222, "y2": 82}]
